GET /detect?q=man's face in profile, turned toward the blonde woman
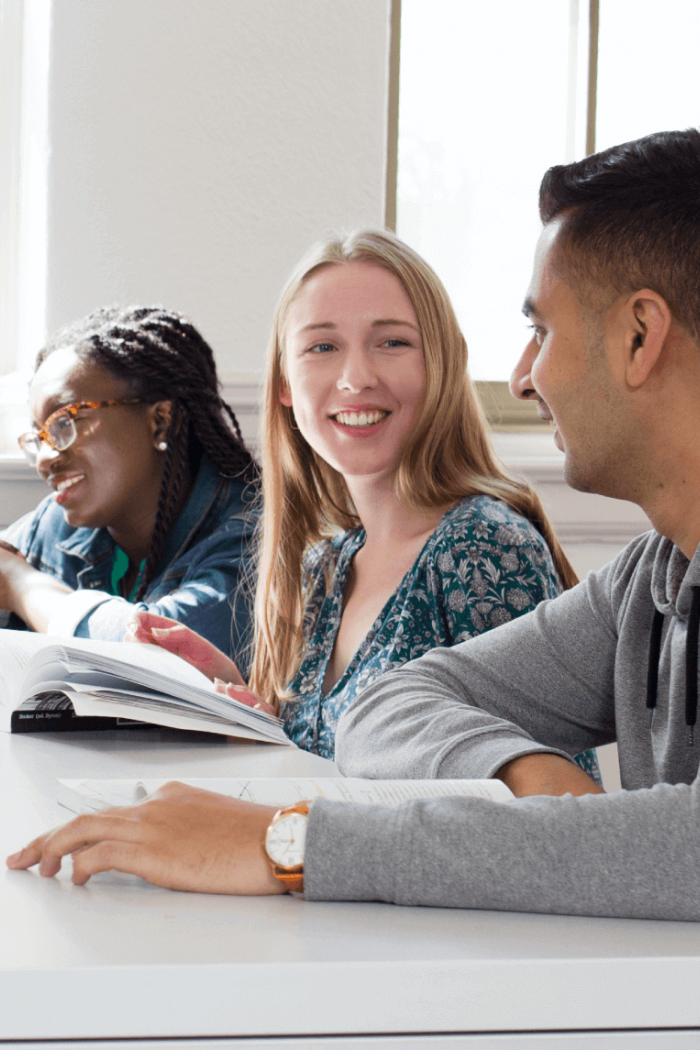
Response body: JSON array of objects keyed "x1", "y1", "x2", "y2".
[{"x1": 510, "y1": 221, "x2": 624, "y2": 496}]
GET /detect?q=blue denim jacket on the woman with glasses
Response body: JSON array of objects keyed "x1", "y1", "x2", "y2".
[{"x1": 1, "y1": 458, "x2": 255, "y2": 673}]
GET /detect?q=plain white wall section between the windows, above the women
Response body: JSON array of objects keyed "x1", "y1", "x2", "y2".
[{"x1": 46, "y1": 0, "x2": 390, "y2": 375}]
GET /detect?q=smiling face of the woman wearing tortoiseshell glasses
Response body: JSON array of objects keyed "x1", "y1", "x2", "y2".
[{"x1": 29, "y1": 349, "x2": 168, "y2": 552}]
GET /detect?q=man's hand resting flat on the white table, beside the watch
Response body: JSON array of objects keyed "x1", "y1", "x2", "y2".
[{"x1": 7, "y1": 781, "x2": 284, "y2": 896}]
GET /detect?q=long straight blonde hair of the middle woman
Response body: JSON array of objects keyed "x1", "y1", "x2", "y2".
[{"x1": 251, "y1": 230, "x2": 578, "y2": 710}]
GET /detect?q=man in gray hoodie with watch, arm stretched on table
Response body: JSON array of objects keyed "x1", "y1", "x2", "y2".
[{"x1": 8, "y1": 130, "x2": 700, "y2": 920}]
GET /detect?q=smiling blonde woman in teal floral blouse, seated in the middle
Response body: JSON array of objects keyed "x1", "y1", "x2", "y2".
[{"x1": 131, "y1": 230, "x2": 597, "y2": 775}]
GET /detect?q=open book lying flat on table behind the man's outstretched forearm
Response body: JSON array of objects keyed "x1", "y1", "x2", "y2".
[{"x1": 56, "y1": 777, "x2": 514, "y2": 813}]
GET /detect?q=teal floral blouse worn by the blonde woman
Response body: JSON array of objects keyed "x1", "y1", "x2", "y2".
[{"x1": 281, "y1": 496, "x2": 599, "y2": 779}]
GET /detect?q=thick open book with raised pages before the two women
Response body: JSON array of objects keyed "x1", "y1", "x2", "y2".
[{"x1": 0, "y1": 630, "x2": 289, "y2": 743}]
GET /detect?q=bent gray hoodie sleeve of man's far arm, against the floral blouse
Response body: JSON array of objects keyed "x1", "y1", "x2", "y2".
[{"x1": 336, "y1": 575, "x2": 617, "y2": 778}]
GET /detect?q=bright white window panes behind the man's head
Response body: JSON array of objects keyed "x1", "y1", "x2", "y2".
[{"x1": 397, "y1": 0, "x2": 700, "y2": 380}]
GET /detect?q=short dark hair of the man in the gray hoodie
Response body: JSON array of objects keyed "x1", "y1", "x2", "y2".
[{"x1": 539, "y1": 128, "x2": 700, "y2": 342}]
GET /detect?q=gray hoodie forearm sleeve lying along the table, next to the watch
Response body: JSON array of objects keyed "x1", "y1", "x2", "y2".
[{"x1": 304, "y1": 780, "x2": 700, "y2": 921}]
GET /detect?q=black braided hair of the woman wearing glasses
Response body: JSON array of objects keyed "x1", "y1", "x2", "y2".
[{"x1": 36, "y1": 307, "x2": 259, "y2": 602}]
